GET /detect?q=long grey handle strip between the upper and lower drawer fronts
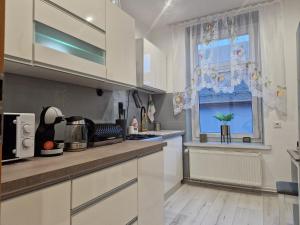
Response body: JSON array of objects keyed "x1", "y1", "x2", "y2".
[{"x1": 71, "y1": 178, "x2": 138, "y2": 216}]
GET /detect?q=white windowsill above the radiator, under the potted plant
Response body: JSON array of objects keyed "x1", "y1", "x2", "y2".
[{"x1": 184, "y1": 141, "x2": 272, "y2": 150}]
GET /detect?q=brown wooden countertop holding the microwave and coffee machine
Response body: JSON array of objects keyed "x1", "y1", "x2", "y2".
[{"x1": 1, "y1": 141, "x2": 166, "y2": 200}]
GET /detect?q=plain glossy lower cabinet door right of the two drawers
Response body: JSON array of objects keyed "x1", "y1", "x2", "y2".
[{"x1": 138, "y1": 151, "x2": 164, "y2": 225}]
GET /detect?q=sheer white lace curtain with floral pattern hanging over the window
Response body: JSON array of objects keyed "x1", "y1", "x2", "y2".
[{"x1": 179, "y1": 3, "x2": 286, "y2": 117}]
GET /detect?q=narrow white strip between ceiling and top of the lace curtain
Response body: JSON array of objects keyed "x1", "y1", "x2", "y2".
[{"x1": 170, "y1": 0, "x2": 280, "y2": 26}]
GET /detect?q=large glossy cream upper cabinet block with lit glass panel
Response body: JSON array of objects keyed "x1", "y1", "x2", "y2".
[{"x1": 5, "y1": 0, "x2": 137, "y2": 88}]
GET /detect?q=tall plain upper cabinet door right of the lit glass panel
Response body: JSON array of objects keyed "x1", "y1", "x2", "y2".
[{"x1": 106, "y1": 0, "x2": 136, "y2": 86}]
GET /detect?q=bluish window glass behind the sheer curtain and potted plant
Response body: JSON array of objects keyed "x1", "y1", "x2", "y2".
[{"x1": 197, "y1": 34, "x2": 261, "y2": 139}]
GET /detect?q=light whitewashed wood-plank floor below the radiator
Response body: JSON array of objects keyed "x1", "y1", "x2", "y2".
[{"x1": 165, "y1": 185, "x2": 293, "y2": 225}]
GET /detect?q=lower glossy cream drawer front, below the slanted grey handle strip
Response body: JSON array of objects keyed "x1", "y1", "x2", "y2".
[{"x1": 72, "y1": 183, "x2": 137, "y2": 225}]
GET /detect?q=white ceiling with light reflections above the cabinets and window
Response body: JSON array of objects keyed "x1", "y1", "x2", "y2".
[{"x1": 121, "y1": 0, "x2": 265, "y2": 27}]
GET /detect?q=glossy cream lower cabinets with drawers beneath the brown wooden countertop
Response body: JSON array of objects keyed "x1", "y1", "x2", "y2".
[{"x1": 1, "y1": 151, "x2": 164, "y2": 225}]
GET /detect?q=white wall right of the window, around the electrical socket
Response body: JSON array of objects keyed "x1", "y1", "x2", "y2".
[{"x1": 263, "y1": 0, "x2": 300, "y2": 188}]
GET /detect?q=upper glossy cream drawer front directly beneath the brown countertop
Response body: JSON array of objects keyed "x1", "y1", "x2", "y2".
[{"x1": 72, "y1": 160, "x2": 137, "y2": 208}]
